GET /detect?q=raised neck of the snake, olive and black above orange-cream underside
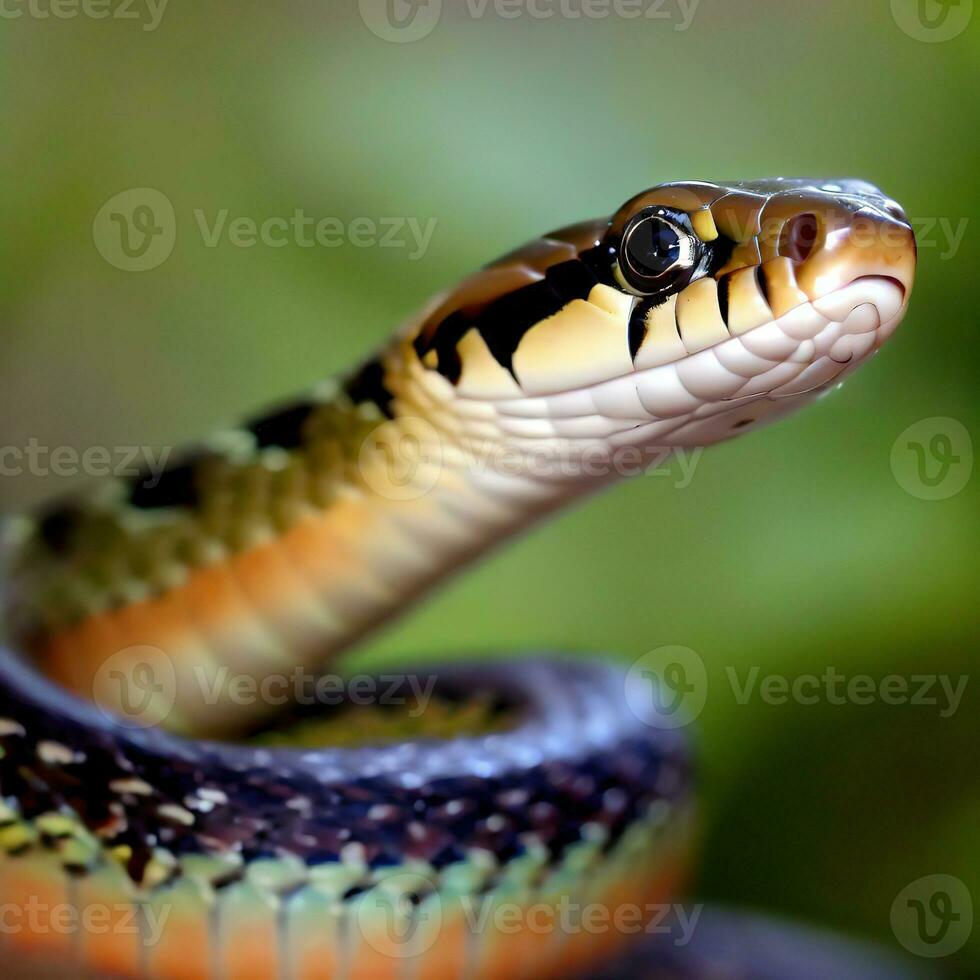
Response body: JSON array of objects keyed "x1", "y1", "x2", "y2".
[{"x1": 5, "y1": 331, "x2": 581, "y2": 735}]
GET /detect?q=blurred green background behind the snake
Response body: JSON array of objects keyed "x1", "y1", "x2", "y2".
[{"x1": 0, "y1": 0, "x2": 980, "y2": 970}]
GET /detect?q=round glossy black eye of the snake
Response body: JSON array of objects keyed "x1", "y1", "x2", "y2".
[{"x1": 620, "y1": 208, "x2": 701, "y2": 295}]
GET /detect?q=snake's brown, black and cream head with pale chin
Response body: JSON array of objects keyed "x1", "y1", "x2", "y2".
[{"x1": 411, "y1": 178, "x2": 916, "y2": 445}]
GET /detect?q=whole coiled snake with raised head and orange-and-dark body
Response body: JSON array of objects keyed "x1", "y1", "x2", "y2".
[{"x1": 0, "y1": 178, "x2": 916, "y2": 980}]
